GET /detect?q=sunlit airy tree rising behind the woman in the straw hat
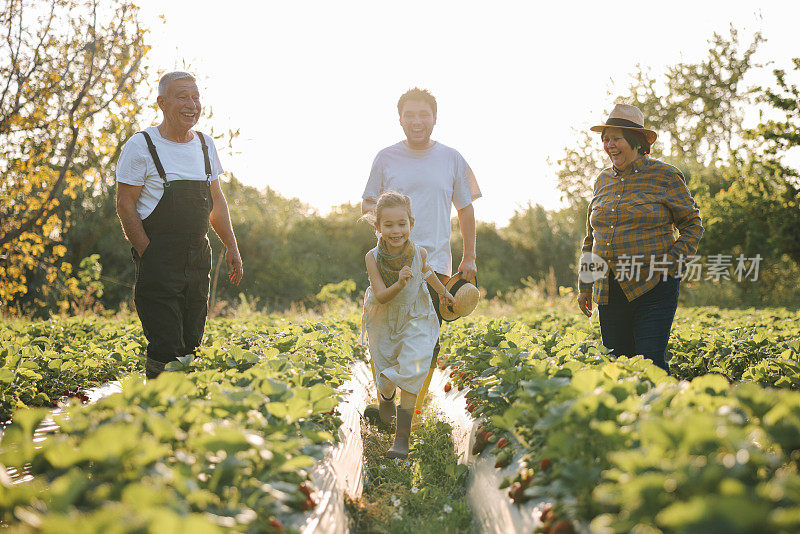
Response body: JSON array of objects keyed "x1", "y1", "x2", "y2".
[{"x1": 557, "y1": 27, "x2": 764, "y2": 204}]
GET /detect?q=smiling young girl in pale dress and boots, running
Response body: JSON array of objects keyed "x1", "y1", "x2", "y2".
[{"x1": 362, "y1": 191, "x2": 455, "y2": 458}]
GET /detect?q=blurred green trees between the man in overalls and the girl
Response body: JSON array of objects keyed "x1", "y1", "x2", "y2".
[{"x1": 202, "y1": 177, "x2": 375, "y2": 314}]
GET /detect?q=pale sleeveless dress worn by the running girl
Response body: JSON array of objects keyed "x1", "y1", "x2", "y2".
[{"x1": 361, "y1": 245, "x2": 439, "y2": 394}]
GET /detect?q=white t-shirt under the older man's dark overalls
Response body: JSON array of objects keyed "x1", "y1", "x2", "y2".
[{"x1": 117, "y1": 126, "x2": 224, "y2": 219}]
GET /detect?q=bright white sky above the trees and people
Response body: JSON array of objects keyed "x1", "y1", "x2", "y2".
[{"x1": 138, "y1": 0, "x2": 800, "y2": 225}]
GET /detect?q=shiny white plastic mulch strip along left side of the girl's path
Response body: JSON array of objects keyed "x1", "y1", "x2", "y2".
[{"x1": 302, "y1": 362, "x2": 375, "y2": 534}]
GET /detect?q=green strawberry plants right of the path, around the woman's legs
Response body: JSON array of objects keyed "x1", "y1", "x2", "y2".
[{"x1": 441, "y1": 310, "x2": 800, "y2": 532}]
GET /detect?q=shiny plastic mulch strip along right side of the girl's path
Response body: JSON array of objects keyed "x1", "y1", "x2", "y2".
[{"x1": 428, "y1": 368, "x2": 548, "y2": 534}]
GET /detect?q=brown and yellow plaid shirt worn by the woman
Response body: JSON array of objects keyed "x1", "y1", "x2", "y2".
[{"x1": 579, "y1": 155, "x2": 703, "y2": 304}]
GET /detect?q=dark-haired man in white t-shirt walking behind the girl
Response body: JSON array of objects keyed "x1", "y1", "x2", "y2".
[{"x1": 361, "y1": 88, "x2": 481, "y2": 420}]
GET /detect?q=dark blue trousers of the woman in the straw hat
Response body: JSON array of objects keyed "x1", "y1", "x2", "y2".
[{"x1": 597, "y1": 276, "x2": 679, "y2": 373}]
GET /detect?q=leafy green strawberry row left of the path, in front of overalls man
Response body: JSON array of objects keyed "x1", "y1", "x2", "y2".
[{"x1": 0, "y1": 319, "x2": 356, "y2": 533}]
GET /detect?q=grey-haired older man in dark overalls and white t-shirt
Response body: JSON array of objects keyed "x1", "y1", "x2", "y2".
[{"x1": 117, "y1": 72, "x2": 243, "y2": 378}]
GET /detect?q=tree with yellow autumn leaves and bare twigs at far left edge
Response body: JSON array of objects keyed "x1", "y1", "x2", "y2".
[{"x1": 0, "y1": 0, "x2": 147, "y2": 311}]
